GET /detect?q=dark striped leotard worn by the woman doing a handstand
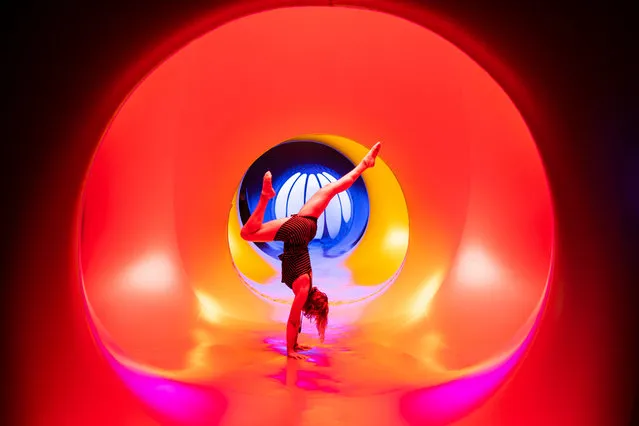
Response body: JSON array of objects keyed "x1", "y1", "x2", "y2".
[{"x1": 275, "y1": 214, "x2": 317, "y2": 289}]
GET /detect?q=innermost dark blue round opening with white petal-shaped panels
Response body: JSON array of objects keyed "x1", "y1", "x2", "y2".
[{"x1": 237, "y1": 140, "x2": 370, "y2": 259}]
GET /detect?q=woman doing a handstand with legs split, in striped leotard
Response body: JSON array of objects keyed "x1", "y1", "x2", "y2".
[{"x1": 240, "y1": 142, "x2": 381, "y2": 359}]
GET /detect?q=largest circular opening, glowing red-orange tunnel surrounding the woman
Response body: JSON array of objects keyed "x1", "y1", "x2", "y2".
[{"x1": 80, "y1": 7, "x2": 553, "y2": 424}]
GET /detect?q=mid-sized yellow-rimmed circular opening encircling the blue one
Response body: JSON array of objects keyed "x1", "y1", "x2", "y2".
[{"x1": 229, "y1": 135, "x2": 409, "y2": 325}]
